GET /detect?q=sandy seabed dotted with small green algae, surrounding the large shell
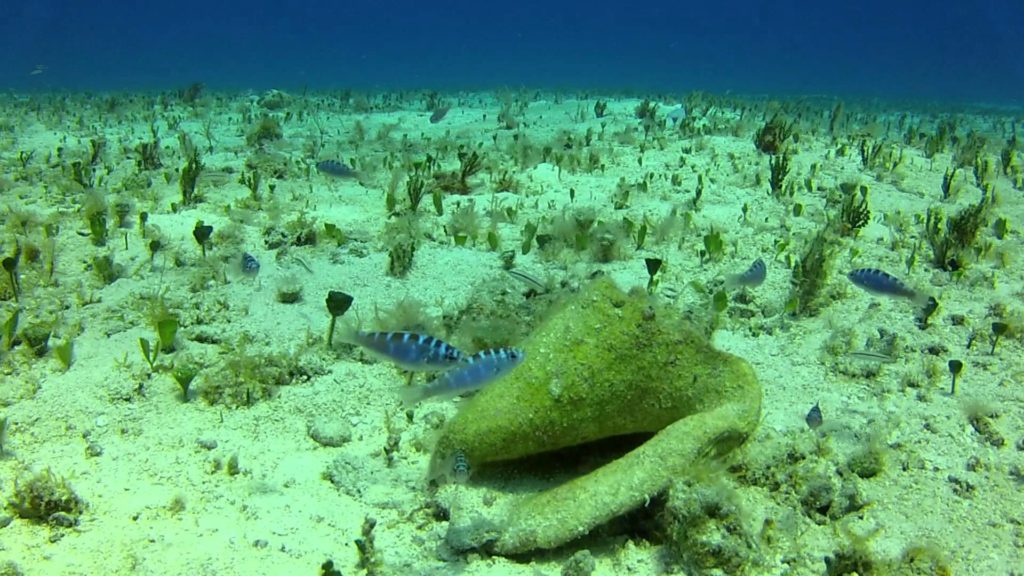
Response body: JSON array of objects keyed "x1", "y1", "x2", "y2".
[{"x1": 0, "y1": 87, "x2": 1024, "y2": 575}]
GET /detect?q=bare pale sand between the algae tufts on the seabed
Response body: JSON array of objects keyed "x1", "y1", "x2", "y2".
[{"x1": 0, "y1": 88, "x2": 1024, "y2": 575}]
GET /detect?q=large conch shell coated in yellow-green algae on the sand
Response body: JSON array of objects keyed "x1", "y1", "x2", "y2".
[{"x1": 430, "y1": 280, "x2": 761, "y2": 553}]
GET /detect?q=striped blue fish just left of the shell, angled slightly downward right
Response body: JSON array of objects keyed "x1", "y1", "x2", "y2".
[{"x1": 346, "y1": 330, "x2": 465, "y2": 371}]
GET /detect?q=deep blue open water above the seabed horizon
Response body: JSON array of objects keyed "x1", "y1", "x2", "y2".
[{"x1": 0, "y1": 0, "x2": 1024, "y2": 105}]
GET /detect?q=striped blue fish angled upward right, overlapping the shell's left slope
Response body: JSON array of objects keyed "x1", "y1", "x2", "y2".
[{"x1": 402, "y1": 348, "x2": 526, "y2": 406}]
